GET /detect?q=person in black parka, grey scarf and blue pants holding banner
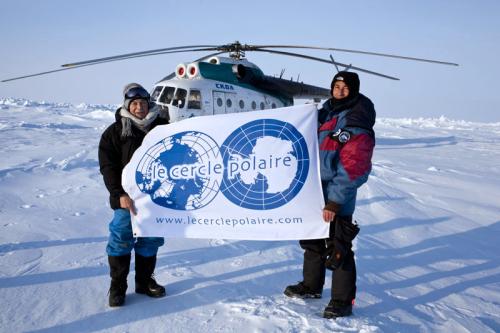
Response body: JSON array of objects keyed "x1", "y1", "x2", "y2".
[{"x1": 99, "y1": 83, "x2": 168, "y2": 307}]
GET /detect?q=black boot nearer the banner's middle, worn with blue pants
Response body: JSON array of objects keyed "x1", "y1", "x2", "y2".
[{"x1": 135, "y1": 253, "x2": 166, "y2": 297}]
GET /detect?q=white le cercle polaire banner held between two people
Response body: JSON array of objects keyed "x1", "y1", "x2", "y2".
[{"x1": 122, "y1": 104, "x2": 328, "y2": 240}]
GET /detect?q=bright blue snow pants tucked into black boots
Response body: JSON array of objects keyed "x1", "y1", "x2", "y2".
[{"x1": 106, "y1": 208, "x2": 164, "y2": 257}]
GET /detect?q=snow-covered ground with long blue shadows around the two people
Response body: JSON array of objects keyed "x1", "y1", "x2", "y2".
[{"x1": 0, "y1": 98, "x2": 500, "y2": 333}]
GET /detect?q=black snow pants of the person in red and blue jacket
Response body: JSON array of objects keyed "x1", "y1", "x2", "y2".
[{"x1": 300, "y1": 216, "x2": 359, "y2": 303}]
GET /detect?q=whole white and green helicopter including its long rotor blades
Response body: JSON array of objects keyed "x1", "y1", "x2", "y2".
[{"x1": 1, "y1": 41, "x2": 458, "y2": 122}]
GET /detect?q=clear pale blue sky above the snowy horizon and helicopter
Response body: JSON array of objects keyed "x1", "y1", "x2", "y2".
[{"x1": 0, "y1": 0, "x2": 500, "y2": 122}]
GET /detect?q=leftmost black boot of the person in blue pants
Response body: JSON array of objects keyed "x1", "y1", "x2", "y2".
[{"x1": 108, "y1": 254, "x2": 130, "y2": 307}]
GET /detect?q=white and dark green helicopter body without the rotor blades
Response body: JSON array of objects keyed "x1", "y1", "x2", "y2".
[{"x1": 151, "y1": 57, "x2": 293, "y2": 122}]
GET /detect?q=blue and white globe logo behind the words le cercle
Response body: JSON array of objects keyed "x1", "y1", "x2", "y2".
[{"x1": 135, "y1": 131, "x2": 223, "y2": 210}]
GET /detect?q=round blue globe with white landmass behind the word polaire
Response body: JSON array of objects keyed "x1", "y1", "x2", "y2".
[{"x1": 221, "y1": 119, "x2": 309, "y2": 210}]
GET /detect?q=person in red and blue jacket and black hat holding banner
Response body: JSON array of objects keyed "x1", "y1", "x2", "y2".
[{"x1": 285, "y1": 71, "x2": 376, "y2": 318}]
